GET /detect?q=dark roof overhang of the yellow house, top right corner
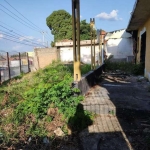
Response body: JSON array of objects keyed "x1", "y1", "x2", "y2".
[{"x1": 126, "y1": 0, "x2": 150, "y2": 31}]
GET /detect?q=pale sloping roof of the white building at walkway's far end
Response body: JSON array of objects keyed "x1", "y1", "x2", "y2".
[{"x1": 105, "y1": 29, "x2": 132, "y2": 40}]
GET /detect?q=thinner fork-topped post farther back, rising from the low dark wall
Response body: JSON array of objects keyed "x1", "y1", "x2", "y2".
[{"x1": 90, "y1": 18, "x2": 96, "y2": 70}]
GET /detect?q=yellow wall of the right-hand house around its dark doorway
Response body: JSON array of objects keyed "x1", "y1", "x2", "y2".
[{"x1": 137, "y1": 18, "x2": 150, "y2": 80}]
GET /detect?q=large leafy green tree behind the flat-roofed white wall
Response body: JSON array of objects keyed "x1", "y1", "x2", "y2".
[{"x1": 46, "y1": 10, "x2": 90, "y2": 42}]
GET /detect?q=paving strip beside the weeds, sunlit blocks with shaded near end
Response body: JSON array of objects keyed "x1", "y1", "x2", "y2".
[{"x1": 81, "y1": 86, "x2": 133, "y2": 150}]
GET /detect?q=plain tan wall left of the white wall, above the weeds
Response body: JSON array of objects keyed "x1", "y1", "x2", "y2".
[{"x1": 34, "y1": 48, "x2": 59, "y2": 70}]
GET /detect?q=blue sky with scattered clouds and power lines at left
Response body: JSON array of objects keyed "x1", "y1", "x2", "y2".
[{"x1": 0, "y1": 0, "x2": 135, "y2": 53}]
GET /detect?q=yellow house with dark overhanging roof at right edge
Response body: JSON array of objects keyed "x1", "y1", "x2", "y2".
[{"x1": 126, "y1": 0, "x2": 150, "y2": 80}]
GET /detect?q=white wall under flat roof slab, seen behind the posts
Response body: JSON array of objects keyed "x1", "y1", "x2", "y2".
[{"x1": 60, "y1": 45, "x2": 99, "y2": 64}]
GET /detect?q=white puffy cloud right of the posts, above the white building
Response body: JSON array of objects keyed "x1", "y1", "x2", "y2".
[{"x1": 96, "y1": 10, "x2": 122, "y2": 21}]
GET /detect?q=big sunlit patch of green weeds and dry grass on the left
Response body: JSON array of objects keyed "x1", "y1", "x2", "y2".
[{"x1": 0, "y1": 62, "x2": 92, "y2": 148}]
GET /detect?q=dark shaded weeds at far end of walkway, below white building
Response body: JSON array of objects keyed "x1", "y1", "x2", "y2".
[{"x1": 105, "y1": 60, "x2": 144, "y2": 75}]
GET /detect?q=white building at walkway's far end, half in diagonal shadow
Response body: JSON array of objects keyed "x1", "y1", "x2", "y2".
[{"x1": 104, "y1": 29, "x2": 134, "y2": 62}]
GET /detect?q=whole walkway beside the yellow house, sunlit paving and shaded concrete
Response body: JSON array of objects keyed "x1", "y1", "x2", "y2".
[{"x1": 80, "y1": 76, "x2": 150, "y2": 150}]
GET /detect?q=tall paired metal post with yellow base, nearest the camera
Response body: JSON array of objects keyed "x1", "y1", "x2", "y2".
[{"x1": 72, "y1": 0, "x2": 81, "y2": 82}]
